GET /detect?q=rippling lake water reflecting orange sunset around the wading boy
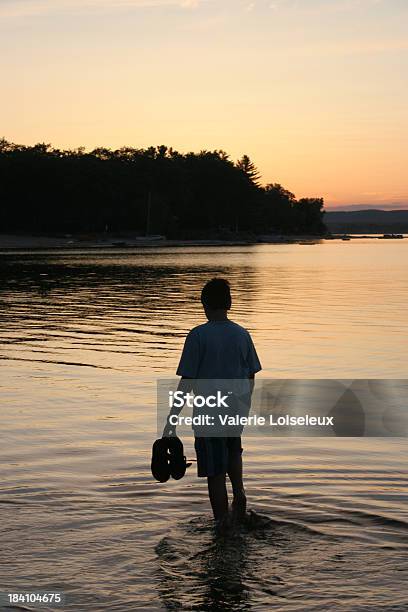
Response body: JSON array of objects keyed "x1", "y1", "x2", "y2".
[{"x1": 0, "y1": 239, "x2": 408, "y2": 611}]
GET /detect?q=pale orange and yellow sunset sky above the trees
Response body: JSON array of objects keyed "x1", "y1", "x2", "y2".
[{"x1": 0, "y1": 0, "x2": 408, "y2": 208}]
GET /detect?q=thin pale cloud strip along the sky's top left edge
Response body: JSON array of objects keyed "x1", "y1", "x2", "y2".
[{"x1": 0, "y1": 0, "x2": 203, "y2": 18}]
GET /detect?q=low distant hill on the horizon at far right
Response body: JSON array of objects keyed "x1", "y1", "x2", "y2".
[{"x1": 324, "y1": 209, "x2": 408, "y2": 234}]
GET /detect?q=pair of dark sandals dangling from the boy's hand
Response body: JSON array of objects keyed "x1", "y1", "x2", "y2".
[{"x1": 151, "y1": 436, "x2": 191, "y2": 482}]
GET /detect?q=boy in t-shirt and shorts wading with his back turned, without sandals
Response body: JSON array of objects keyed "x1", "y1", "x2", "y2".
[{"x1": 163, "y1": 278, "x2": 262, "y2": 522}]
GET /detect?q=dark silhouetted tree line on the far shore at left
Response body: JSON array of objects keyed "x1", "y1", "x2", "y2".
[{"x1": 0, "y1": 139, "x2": 326, "y2": 238}]
